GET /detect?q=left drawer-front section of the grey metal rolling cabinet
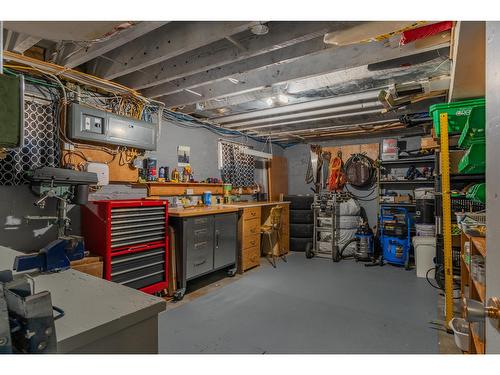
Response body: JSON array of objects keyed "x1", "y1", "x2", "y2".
[{"x1": 184, "y1": 215, "x2": 214, "y2": 280}]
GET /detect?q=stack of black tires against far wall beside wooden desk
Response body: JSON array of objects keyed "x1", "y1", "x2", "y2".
[{"x1": 284, "y1": 195, "x2": 314, "y2": 251}]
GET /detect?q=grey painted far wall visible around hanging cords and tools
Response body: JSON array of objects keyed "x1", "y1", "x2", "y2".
[{"x1": 285, "y1": 136, "x2": 421, "y2": 227}]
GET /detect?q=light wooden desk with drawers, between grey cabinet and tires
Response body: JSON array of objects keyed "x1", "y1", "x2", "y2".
[{"x1": 224, "y1": 201, "x2": 290, "y2": 273}]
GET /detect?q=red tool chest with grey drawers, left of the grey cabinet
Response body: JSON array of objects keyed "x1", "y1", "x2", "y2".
[{"x1": 82, "y1": 199, "x2": 168, "y2": 294}]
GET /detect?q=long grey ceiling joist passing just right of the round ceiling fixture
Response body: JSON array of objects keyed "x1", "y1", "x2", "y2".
[{"x1": 116, "y1": 22, "x2": 360, "y2": 90}]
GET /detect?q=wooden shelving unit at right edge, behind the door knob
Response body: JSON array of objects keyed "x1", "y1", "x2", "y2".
[{"x1": 460, "y1": 232, "x2": 486, "y2": 354}]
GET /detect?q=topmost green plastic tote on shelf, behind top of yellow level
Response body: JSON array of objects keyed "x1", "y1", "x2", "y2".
[{"x1": 429, "y1": 98, "x2": 485, "y2": 137}]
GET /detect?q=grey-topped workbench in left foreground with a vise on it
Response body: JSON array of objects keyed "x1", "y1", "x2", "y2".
[{"x1": 0, "y1": 246, "x2": 166, "y2": 354}]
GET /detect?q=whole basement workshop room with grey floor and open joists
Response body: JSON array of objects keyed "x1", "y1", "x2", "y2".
[{"x1": 0, "y1": 17, "x2": 500, "y2": 361}]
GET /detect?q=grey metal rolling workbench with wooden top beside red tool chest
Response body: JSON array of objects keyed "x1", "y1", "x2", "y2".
[{"x1": 169, "y1": 206, "x2": 238, "y2": 300}]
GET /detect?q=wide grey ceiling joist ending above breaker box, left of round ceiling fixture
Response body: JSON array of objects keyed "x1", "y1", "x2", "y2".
[{"x1": 91, "y1": 21, "x2": 257, "y2": 79}]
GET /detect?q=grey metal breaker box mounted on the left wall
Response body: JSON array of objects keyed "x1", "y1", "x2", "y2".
[{"x1": 68, "y1": 103, "x2": 158, "y2": 150}]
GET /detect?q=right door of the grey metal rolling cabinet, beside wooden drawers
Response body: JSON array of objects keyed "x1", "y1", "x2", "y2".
[{"x1": 214, "y1": 213, "x2": 238, "y2": 268}]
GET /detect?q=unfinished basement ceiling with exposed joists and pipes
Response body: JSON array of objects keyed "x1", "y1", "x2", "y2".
[{"x1": 0, "y1": 21, "x2": 451, "y2": 142}]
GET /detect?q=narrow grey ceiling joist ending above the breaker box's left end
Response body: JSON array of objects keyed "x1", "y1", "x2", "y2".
[{"x1": 59, "y1": 21, "x2": 168, "y2": 68}]
